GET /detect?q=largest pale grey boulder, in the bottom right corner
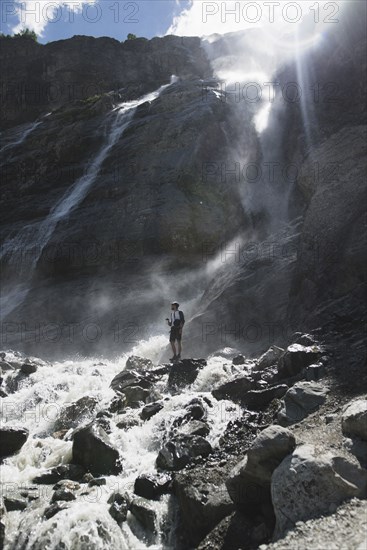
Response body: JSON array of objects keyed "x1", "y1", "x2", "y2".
[{"x1": 271, "y1": 445, "x2": 367, "y2": 538}]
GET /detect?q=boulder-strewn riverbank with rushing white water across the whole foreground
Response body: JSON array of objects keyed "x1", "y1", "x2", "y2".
[{"x1": 1, "y1": 333, "x2": 367, "y2": 550}]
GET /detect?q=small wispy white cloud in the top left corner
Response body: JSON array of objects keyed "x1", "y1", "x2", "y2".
[{"x1": 11, "y1": 0, "x2": 98, "y2": 36}]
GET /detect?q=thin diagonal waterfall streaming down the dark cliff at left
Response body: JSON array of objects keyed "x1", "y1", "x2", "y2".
[{"x1": 0, "y1": 76, "x2": 177, "y2": 319}]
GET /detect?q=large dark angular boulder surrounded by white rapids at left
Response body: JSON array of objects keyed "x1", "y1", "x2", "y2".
[{"x1": 72, "y1": 423, "x2": 122, "y2": 475}]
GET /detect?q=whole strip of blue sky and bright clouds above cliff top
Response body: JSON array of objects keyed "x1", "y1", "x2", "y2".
[{"x1": 0, "y1": 0, "x2": 348, "y2": 43}]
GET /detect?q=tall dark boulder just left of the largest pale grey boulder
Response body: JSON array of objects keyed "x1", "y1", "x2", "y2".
[{"x1": 226, "y1": 426, "x2": 295, "y2": 520}]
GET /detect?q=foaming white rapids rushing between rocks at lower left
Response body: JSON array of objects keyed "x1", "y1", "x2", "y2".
[{"x1": 1, "y1": 336, "x2": 241, "y2": 550}]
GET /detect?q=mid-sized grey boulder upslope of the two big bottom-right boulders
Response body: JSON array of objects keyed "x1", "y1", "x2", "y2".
[{"x1": 278, "y1": 382, "x2": 329, "y2": 426}]
